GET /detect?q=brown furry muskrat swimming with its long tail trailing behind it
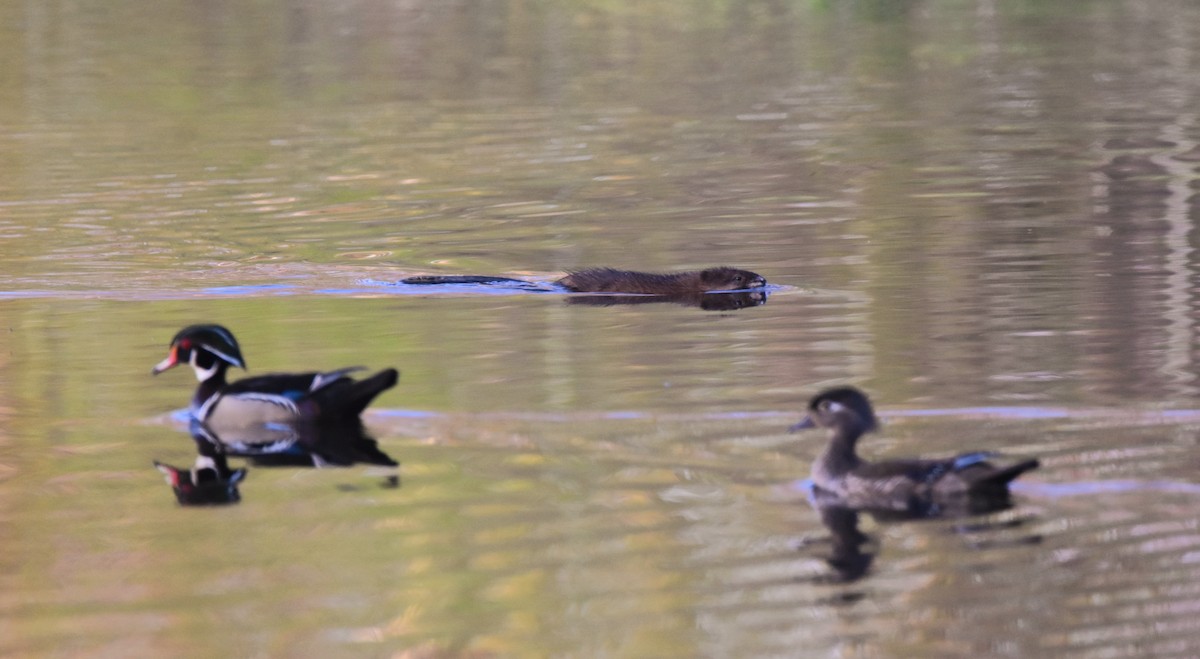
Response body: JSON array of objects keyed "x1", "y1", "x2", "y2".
[{"x1": 401, "y1": 266, "x2": 767, "y2": 296}]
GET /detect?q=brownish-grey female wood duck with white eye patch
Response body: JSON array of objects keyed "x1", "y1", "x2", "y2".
[{"x1": 790, "y1": 387, "x2": 1038, "y2": 516}]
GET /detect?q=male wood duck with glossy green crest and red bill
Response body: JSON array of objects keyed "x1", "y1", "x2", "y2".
[{"x1": 151, "y1": 324, "x2": 400, "y2": 430}]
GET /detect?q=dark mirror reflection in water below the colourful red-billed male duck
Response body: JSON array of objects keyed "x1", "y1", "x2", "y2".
[{"x1": 155, "y1": 419, "x2": 400, "y2": 505}]
